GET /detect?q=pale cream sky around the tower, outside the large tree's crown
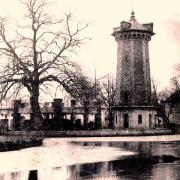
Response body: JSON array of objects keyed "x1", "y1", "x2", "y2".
[{"x1": 0, "y1": 0, "x2": 180, "y2": 96}]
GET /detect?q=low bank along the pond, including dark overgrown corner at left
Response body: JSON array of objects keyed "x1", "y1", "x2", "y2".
[{"x1": 0, "y1": 129, "x2": 172, "y2": 152}]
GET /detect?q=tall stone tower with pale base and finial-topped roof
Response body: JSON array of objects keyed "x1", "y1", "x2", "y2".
[{"x1": 112, "y1": 11, "x2": 156, "y2": 128}]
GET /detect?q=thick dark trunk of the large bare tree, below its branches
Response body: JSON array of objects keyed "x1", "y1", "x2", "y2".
[{"x1": 31, "y1": 84, "x2": 43, "y2": 131}]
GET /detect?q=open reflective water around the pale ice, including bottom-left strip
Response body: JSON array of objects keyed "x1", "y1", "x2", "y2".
[{"x1": 0, "y1": 139, "x2": 180, "y2": 180}]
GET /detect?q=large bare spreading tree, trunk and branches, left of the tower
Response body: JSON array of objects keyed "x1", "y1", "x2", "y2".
[{"x1": 0, "y1": 0, "x2": 87, "y2": 130}]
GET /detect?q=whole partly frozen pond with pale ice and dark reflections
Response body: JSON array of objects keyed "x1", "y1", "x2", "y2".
[{"x1": 0, "y1": 135, "x2": 180, "y2": 180}]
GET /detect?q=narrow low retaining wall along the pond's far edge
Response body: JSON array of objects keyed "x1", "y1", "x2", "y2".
[{"x1": 7, "y1": 128, "x2": 172, "y2": 137}]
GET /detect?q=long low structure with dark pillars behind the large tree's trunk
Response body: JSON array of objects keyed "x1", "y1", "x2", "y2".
[{"x1": 0, "y1": 99, "x2": 107, "y2": 130}]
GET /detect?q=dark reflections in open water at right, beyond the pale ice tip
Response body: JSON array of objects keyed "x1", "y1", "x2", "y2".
[{"x1": 68, "y1": 142, "x2": 180, "y2": 180}]
